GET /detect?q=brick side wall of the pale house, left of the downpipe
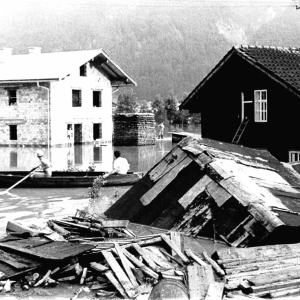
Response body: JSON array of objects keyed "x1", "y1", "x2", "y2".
[{"x1": 0, "y1": 83, "x2": 48, "y2": 145}]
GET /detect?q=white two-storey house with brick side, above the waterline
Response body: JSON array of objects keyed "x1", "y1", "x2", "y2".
[{"x1": 0, "y1": 47, "x2": 136, "y2": 146}]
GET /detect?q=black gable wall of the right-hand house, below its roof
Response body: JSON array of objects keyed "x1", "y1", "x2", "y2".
[{"x1": 184, "y1": 54, "x2": 300, "y2": 161}]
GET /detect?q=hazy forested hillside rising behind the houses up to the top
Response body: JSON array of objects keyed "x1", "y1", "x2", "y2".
[{"x1": 0, "y1": 0, "x2": 300, "y2": 101}]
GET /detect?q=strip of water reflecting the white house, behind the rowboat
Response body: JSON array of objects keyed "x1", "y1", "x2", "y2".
[{"x1": 0, "y1": 138, "x2": 174, "y2": 172}]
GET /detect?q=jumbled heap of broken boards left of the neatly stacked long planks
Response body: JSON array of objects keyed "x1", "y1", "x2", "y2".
[{"x1": 0, "y1": 214, "x2": 231, "y2": 300}]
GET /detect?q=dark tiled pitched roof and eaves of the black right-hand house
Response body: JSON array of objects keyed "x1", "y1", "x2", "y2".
[{"x1": 180, "y1": 46, "x2": 300, "y2": 109}]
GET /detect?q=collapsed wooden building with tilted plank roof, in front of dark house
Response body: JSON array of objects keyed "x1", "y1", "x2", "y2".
[{"x1": 105, "y1": 137, "x2": 300, "y2": 246}]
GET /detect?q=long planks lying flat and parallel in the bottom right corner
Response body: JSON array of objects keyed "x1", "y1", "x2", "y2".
[{"x1": 215, "y1": 244, "x2": 300, "y2": 298}]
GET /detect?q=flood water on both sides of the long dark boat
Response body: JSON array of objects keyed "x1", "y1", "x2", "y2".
[{"x1": 0, "y1": 138, "x2": 175, "y2": 236}]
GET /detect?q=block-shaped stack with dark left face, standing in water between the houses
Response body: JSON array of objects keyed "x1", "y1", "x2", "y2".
[{"x1": 113, "y1": 113, "x2": 156, "y2": 146}]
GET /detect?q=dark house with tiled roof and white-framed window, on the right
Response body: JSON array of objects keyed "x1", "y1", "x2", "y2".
[{"x1": 180, "y1": 46, "x2": 300, "y2": 162}]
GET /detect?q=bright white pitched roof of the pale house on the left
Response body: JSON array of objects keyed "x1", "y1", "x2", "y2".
[{"x1": 0, "y1": 49, "x2": 136, "y2": 86}]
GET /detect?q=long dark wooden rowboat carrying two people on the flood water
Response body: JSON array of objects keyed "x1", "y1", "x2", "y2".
[{"x1": 0, "y1": 171, "x2": 143, "y2": 188}]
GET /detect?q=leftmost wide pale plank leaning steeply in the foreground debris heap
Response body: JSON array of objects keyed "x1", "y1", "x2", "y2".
[{"x1": 101, "y1": 251, "x2": 136, "y2": 298}]
